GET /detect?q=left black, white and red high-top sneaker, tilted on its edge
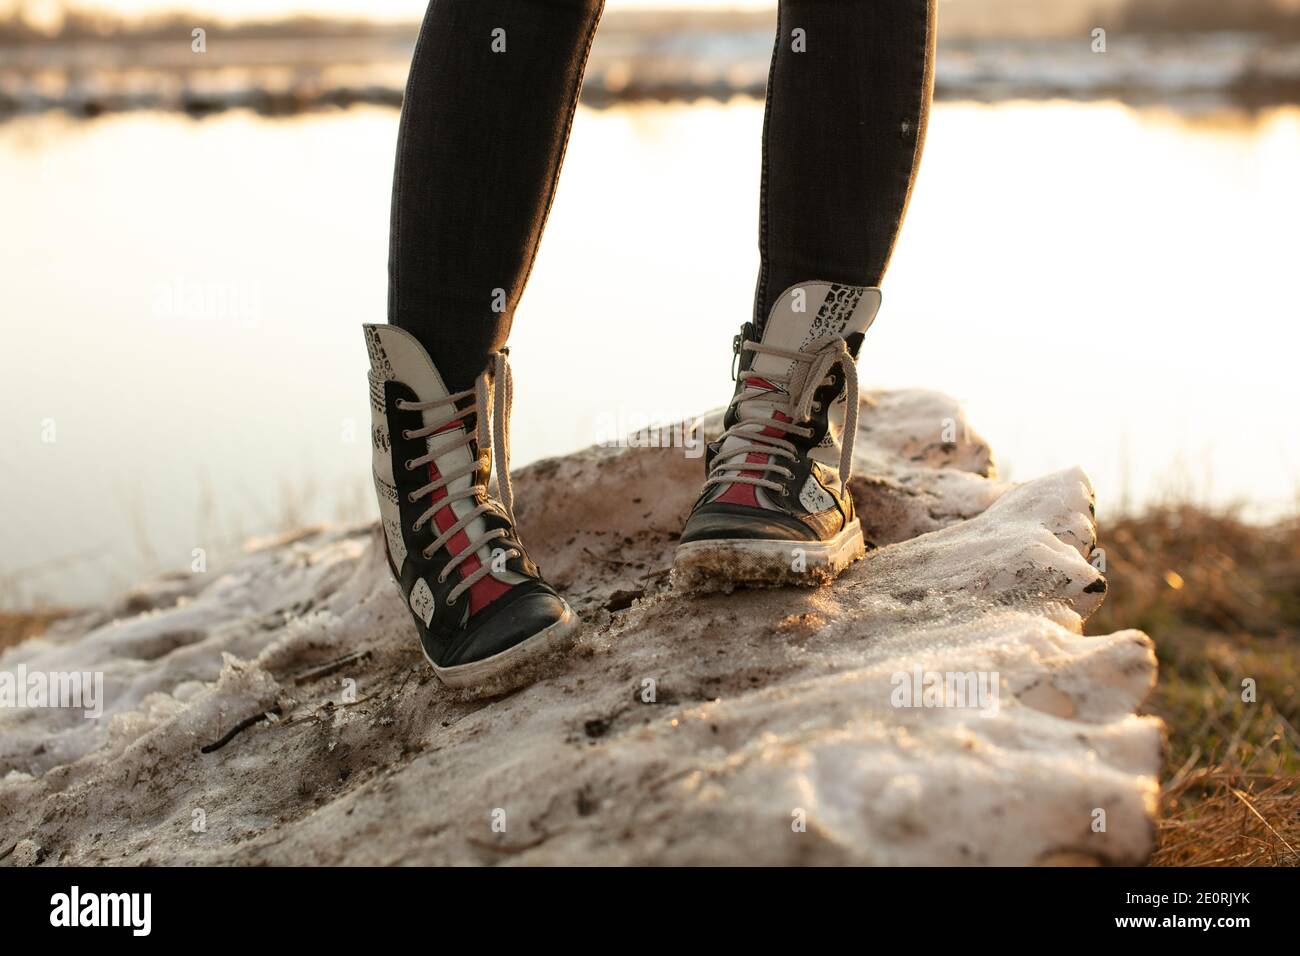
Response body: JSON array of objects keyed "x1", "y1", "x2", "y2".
[{"x1": 365, "y1": 325, "x2": 577, "y2": 689}]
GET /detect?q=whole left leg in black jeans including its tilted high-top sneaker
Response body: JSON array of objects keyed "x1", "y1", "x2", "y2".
[{"x1": 365, "y1": 0, "x2": 601, "y2": 693}]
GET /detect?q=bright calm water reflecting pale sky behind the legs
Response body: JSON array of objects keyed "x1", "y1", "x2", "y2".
[{"x1": 0, "y1": 101, "x2": 1300, "y2": 605}]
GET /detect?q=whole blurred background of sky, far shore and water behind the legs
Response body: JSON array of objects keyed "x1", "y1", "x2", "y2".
[{"x1": 0, "y1": 0, "x2": 1300, "y2": 609}]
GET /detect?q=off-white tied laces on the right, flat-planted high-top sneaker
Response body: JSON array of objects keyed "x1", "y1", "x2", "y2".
[{"x1": 705, "y1": 336, "x2": 858, "y2": 492}]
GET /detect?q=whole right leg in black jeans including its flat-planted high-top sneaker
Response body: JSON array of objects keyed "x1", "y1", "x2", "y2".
[{"x1": 673, "y1": 0, "x2": 935, "y2": 588}]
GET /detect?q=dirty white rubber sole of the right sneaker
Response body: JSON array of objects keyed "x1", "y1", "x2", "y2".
[{"x1": 672, "y1": 518, "x2": 867, "y2": 589}]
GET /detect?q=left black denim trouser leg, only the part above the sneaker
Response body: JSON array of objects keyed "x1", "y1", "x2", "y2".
[{"x1": 389, "y1": 0, "x2": 603, "y2": 392}]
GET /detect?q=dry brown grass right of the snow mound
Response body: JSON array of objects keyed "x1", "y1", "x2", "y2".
[{"x1": 1089, "y1": 506, "x2": 1300, "y2": 866}]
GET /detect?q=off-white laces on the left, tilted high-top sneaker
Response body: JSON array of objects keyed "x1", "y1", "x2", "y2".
[{"x1": 397, "y1": 350, "x2": 520, "y2": 605}]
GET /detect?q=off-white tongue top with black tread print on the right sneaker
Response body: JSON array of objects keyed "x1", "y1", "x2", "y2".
[{"x1": 750, "y1": 282, "x2": 880, "y2": 378}]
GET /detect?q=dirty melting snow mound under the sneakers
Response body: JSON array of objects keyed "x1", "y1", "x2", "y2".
[{"x1": 0, "y1": 392, "x2": 1162, "y2": 865}]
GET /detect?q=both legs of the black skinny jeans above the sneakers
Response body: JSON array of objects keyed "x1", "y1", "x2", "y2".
[{"x1": 389, "y1": 0, "x2": 935, "y2": 390}]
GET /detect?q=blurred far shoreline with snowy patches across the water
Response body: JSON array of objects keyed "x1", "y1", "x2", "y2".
[{"x1": 0, "y1": 12, "x2": 1300, "y2": 122}]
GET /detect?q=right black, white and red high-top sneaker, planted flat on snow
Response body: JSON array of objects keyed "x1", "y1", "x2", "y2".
[{"x1": 673, "y1": 282, "x2": 880, "y2": 589}]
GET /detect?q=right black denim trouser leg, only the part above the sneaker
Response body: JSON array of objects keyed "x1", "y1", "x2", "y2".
[{"x1": 754, "y1": 0, "x2": 935, "y2": 328}]
